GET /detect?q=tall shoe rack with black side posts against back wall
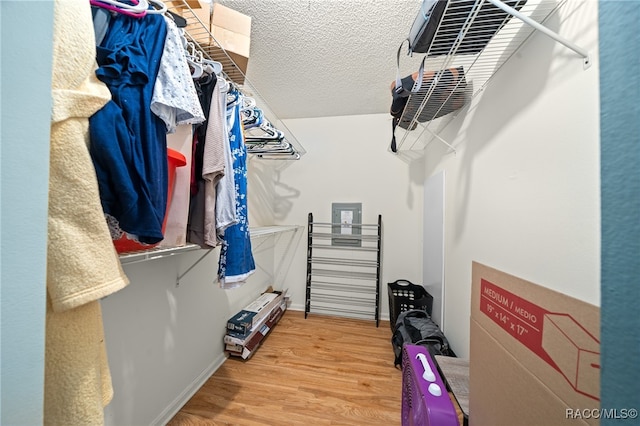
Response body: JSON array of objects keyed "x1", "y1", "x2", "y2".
[{"x1": 304, "y1": 213, "x2": 382, "y2": 327}]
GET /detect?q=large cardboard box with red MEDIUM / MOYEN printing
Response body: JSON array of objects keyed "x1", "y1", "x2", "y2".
[{"x1": 469, "y1": 262, "x2": 600, "y2": 426}]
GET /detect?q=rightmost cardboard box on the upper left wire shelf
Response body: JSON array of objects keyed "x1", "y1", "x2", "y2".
[{"x1": 209, "y1": 3, "x2": 251, "y2": 84}]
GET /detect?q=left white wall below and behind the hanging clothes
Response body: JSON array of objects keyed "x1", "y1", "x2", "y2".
[{"x1": 102, "y1": 155, "x2": 290, "y2": 426}]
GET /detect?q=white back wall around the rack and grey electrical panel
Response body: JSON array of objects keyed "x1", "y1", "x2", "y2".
[{"x1": 274, "y1": 114, "x2": 424, "y2": 318}]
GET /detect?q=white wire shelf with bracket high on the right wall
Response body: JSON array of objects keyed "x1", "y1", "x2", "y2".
[{"x1": 396, "y1": 0, "x2": 590, "y2": 152}]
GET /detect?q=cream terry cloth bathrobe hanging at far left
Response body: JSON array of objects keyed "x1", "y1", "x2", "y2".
[{"x1": 43, "y1": 0, "x2": 129, "y2": 425}]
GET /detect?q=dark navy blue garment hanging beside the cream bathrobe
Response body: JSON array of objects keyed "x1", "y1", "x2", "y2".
[{"x1": 90, "y1": 10, "x2": 168, "y2": 244}]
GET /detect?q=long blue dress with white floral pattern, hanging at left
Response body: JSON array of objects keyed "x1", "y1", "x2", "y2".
[{"x1": 218, "y1": 90, "x2": 255, "y2": 288}]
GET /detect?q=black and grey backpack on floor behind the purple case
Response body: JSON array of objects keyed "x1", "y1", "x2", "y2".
[{"x1": 391, "y1": 309, "x2": 455, "y2": 367}]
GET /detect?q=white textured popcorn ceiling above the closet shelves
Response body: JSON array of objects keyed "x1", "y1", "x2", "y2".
[{"x1": 215, "y1": 0, "x2": 421, "y2": 119}]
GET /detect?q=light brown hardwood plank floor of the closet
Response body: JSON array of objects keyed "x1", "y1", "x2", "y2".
[{"x1": 168, "y1": 311, "x2": 402, "y2": 426}]
